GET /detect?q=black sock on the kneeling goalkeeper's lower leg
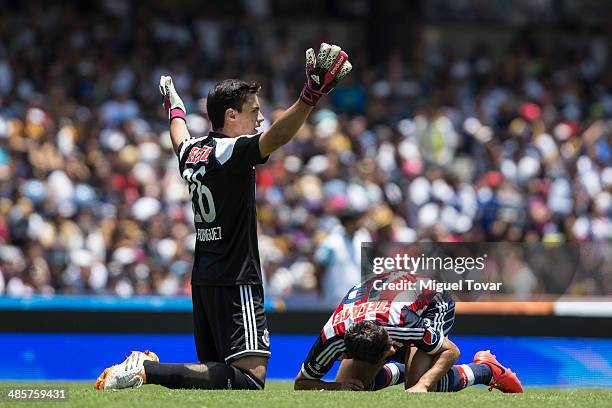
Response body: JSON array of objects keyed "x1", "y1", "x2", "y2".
[{"x1": 144, "y1": 361, "x2": 264, "y2": 390}]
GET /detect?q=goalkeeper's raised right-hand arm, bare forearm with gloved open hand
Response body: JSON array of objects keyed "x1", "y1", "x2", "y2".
[{"x1": 259, "y1": 43, "x2": 352, "y2": 157}]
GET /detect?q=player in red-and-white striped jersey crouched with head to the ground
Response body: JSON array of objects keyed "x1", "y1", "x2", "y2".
[{"x1": 295, "y1": 278, "x2": 522, "y2": 393}]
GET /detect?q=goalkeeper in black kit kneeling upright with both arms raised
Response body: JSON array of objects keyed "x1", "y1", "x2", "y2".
[{"x1": 95, "y1": 43, "x2": 351, "y2": 390}]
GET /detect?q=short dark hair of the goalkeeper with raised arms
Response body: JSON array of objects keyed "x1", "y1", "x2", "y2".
[{"x1": 206, "y1": 79, "x2": 261, "y2": 130}]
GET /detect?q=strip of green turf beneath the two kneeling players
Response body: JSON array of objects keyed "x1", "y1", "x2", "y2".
[{"x1": 0, "y1": 381, "x2": 612, "y2": 408}]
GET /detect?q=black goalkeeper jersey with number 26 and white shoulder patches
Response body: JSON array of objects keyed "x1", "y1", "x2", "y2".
[{"x1": 178, "y1": 132, "x2": 267, "y2": 286}]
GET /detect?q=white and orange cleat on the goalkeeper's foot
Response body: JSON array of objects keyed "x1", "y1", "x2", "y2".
[{"x1": 94, "y1": 351, "x2": 159, "y2": 390}]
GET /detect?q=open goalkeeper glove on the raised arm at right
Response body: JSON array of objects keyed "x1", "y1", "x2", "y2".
[{"x1": 300, "y1": 43, "x2": 353, "y2": 106}]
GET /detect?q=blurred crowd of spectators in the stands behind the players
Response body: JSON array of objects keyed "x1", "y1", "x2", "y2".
[{"x1": 0, "y1": 1, "x2": 612, "y2": 303}]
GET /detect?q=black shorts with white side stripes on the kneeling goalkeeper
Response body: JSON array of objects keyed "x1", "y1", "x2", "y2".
[{"x1": 191, "y1": 285, "x2": 270, "y2": 363}]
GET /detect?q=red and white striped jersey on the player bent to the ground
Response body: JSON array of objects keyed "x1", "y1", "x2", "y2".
[{"x1": 301, "y1": 276, "x2": 454, "y2": 379}]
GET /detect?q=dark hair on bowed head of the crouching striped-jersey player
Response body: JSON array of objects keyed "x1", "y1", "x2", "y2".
[{"x1": 344, "y1": 320, "x2": 391, "y2": 364}]
